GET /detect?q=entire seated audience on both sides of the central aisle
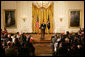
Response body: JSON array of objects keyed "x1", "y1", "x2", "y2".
[{"x1": 0, "y1": 28, "x2": 84, "y2": 56}]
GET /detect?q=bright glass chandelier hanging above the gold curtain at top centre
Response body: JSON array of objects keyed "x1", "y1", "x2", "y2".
[{"x1": 33, "y1": 1, "x2": 52, "y2": 8}]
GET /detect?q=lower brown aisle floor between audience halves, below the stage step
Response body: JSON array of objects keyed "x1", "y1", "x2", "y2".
[{"x1": 34, "y1": 43, "x2": 52, "y2": 56}]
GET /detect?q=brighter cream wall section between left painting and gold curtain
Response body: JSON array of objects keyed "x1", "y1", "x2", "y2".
[{"x1": 17, "y1": 1, "x2": 32, "y2": 32}]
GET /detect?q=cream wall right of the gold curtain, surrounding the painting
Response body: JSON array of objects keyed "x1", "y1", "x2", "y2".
[{"x1": 54, "y1": 1, "x2": 84, "y2": 33}]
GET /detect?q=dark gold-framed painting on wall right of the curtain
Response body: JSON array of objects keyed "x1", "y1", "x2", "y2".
[{"x1": 69, "y1": 10, "x2": 81, "y2": 28}]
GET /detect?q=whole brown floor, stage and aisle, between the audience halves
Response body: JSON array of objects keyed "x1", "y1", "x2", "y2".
[{"x1": 31, "y1": 34, "x2": 59, "y2": 56}]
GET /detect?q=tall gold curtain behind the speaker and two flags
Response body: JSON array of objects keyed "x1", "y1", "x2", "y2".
[{"x1": 32, "y1": 3, "x2": 53, "y2": 33}]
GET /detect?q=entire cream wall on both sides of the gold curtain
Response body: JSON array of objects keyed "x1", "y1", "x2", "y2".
[{"x1": 1, "y1": 1, "x2": 84, "y2": 33}]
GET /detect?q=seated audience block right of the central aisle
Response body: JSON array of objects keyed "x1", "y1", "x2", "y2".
[{"x1": 51, "y1": 29, "x2": 84, "y2": 56}]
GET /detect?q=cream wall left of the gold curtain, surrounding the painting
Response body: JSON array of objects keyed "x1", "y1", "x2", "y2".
[{"x1": 1, "y1": 1, "x2": 32, "y2": 33}]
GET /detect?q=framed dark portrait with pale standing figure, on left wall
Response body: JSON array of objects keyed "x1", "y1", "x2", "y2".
[{"x1": 4, "y1": 10, "x2": 16, "y2": 28}]
